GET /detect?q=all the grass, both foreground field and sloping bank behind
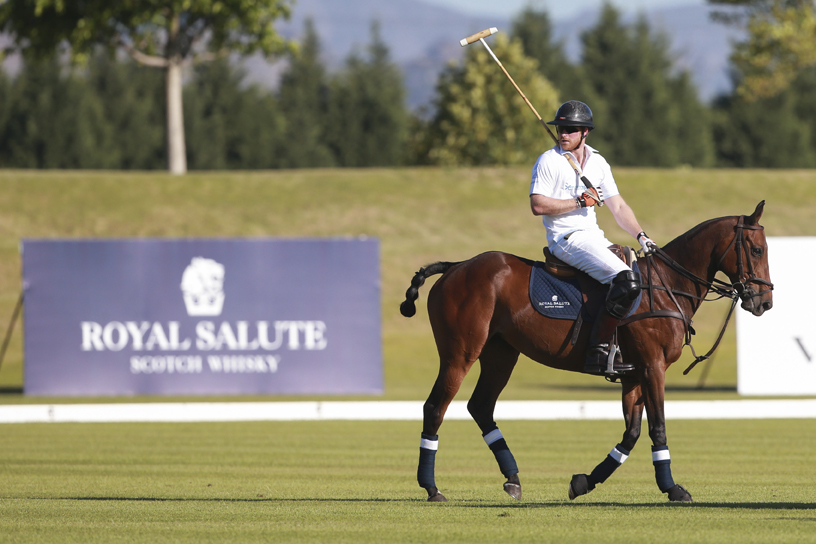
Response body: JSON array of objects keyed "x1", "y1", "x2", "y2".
[{"x1": 0, "y1": 169, "x2": 816, "y2": 543}]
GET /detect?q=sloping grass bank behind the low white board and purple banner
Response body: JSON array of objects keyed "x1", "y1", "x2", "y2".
[{"x1": 0, "y1": 168, "x2": 816, "y2": 402}]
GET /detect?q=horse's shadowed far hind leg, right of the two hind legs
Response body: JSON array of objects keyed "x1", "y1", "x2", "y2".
[{"x1": 468, "y1": 336, "x2": 521, "y2": 499}]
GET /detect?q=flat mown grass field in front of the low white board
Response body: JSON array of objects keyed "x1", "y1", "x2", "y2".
[{"x1": 0, "y1": 420, "x2": 816, "y2": 544}]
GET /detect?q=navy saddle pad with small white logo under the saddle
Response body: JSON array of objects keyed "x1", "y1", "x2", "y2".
[{"x1": 530, "y1": 261, "x2": 643, "y2": 320}]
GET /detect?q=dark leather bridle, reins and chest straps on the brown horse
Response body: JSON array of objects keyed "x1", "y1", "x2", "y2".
[{"x1": 621, "y1": 215, "x2": 773, "y2": 375}]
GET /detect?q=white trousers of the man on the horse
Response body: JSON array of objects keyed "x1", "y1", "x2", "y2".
[{"x1": 550, "y1": 229, "x2": 631, "y2": 285}]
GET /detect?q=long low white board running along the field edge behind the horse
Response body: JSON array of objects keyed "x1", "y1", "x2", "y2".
[{"x1": 0, "y1": 399, "x2": 816, "y2": 423}]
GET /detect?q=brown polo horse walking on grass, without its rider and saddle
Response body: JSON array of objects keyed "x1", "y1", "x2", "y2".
[{"x1": 400, "y1": 201, "x2": 773, "y2": 502}]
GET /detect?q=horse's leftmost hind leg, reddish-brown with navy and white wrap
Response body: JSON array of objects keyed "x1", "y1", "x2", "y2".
[{"x1": 417, "y1": 357, "x2": 475, "y2": 502}]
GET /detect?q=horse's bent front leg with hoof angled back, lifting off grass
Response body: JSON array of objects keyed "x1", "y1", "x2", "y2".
[{"x1": 569, "y1": 377, "x2": 643, "y2": 500}]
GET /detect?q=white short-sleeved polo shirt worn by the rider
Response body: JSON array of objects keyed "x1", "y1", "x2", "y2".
[{"x1": 530, "y1": 144, "x2": 618, "y2": 247}]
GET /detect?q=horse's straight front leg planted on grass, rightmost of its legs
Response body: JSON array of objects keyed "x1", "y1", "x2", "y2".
[{"x1": 644, "y1": 368, "x2": 692, "y2": 502}]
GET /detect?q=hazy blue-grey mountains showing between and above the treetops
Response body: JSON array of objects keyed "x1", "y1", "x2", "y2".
[{"x1": 247, "y1": 0, "x2": 737, "y2": 109}]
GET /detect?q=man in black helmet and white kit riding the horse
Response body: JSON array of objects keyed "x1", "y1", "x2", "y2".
[{"x1": 530, "y1": 100, "x2": 657, "y2": 376}]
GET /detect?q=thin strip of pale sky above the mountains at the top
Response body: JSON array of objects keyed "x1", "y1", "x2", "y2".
[{"x1": 423, "y1": 0, "x2": 706, "y2": 19}]
